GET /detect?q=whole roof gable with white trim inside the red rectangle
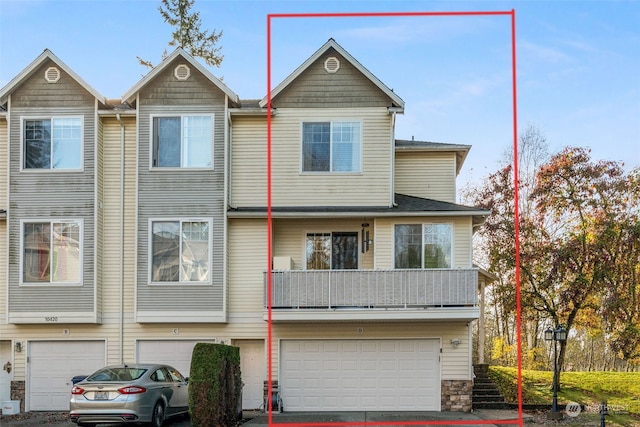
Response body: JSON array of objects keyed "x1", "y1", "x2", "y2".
[{"x1": 260, "y1": 39, "x2": 404, "y2": 112}]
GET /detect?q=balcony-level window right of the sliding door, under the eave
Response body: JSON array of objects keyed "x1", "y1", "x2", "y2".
[{"x1": 395, "y1": 224, "x2": 453, "y2": 268}]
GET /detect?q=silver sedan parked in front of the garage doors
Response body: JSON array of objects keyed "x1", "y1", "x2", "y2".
[{"x1": 69, "y1": 364, "x2": 189, "y2": 427}]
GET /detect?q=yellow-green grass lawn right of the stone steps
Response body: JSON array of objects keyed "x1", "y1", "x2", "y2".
[{"x1": 489, "y1": 366, "x2": 640, "y2": 426}]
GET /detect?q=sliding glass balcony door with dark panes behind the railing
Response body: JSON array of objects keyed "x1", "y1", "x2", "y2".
[{"x1": 306, "y1": 232, "x2": 358, "y2": 270}]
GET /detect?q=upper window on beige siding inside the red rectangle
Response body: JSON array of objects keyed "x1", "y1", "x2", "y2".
[{"x1": 302, "y1": 122, "x2": 362, "y2": 172}]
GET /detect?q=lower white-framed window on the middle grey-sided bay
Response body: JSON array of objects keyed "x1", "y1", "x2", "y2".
[{"x1": 150, "y1": 220, "x2": 211, "y2": 283}]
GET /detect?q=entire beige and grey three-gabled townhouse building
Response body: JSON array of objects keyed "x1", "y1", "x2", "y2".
[{"x1": 0, "y1": 39, "x2": 489, "y2": 411}]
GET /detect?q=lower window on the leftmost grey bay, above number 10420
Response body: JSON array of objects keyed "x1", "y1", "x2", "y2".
[{"x1": 22, "y1": 220, "x2": 82, "y2": 285}]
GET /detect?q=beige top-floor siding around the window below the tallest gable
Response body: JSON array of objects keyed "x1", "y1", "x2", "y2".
[{"x1": 231, "y1": 108, "x2": 391, "y2": 207}]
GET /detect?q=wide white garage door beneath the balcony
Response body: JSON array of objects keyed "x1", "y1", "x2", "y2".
[{"x1": 280, "y1": 339, "x2": 440, "y2": 411}]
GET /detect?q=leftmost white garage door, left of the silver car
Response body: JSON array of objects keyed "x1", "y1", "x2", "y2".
[{"x1": 27, "y1": 341, "x2": 105, "y2": 411}]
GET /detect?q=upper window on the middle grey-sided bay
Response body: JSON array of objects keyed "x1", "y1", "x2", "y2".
[{"x1": 153, "y1": 115, "x2": 213, "y2": 168}]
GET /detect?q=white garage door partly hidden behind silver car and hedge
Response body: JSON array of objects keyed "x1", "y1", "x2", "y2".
[{"x1": 137, "y1": 340, "x2": 214, "y2": 377}]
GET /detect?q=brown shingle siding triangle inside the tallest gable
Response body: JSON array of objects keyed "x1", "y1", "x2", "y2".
[{"x1": 271, "y1": 48, "x2": 392, "y2": 109}]
